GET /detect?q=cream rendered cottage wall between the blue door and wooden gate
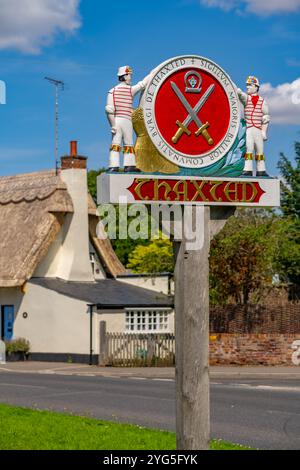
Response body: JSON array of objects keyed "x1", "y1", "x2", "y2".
[{"x1": 0, "y1": 282, "x2": 97, "y2": 354}]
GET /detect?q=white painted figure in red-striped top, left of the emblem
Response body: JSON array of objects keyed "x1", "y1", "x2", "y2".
[{"x1": 105, "y1": 65, "x2": 150, "y2": 172}]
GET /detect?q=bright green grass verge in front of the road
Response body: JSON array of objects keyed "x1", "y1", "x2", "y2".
[{"x1": 0, "y1": 405, "x2": 251, "y2": 450}]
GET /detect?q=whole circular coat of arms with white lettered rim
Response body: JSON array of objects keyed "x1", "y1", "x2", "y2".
[{"x1": 143, "y1": 55, "x2": 240, "y2": 168}]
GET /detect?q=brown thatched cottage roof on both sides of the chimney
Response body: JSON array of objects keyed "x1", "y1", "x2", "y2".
[{"x1": 0, "y1": 171, "x2": 125, "y2": 287}]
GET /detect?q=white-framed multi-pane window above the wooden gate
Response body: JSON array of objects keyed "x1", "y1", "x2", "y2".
[{"x1": 125, "y1": 309, "x2": 171, "y2": 333}]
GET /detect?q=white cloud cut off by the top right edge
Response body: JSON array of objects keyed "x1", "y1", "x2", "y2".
[{"x1": 200, "y1": 0, "x2": 300, "y2": 16}]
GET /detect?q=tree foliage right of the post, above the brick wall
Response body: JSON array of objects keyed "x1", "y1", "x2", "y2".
[{"x1": 210, "y1": 142, "x2": 300, "y2": 304}]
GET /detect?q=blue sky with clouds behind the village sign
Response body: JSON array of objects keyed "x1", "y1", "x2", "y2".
[{"x1": 0, "y1": 0, "x2": 300, "y2": 175}]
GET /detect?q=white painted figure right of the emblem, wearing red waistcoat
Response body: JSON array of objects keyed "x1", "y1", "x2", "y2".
[{"x1": 237, "y1": 76, "x2": 270, "y2": 176}]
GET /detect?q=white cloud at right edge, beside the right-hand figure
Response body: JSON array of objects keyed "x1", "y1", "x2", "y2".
[{"x1": 259, "y1": 78, "x2": 300, "y2": 125}]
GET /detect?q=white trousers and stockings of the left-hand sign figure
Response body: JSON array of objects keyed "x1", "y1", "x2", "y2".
[{"x1": 109, "y1": 117, "x2": 136, "y2": 168}]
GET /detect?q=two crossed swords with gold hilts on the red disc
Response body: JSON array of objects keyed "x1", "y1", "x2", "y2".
[{"x1": 171, "y1": 82, "x2": 215, "y2": 145}]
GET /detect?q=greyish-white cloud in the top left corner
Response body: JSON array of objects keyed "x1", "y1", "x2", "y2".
[{"x1": 0, "y1": 0, "x2": 80, "y2": 54}]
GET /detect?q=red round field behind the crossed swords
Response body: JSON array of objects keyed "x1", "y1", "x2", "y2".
[{"x1": 155, "y1": 67, "x2": 230, "y2": 156}]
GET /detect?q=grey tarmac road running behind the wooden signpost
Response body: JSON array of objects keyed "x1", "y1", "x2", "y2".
[{"x1": 0, "y1": 369, "x2": 300, "y2": 450}]
